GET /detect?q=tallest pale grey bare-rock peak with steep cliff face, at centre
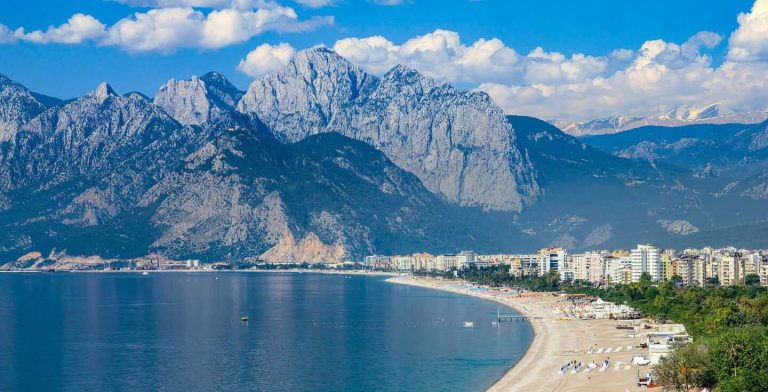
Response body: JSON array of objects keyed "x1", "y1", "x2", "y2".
[{"x1": 238, "y1": 48, "x2": 540, "y2": 211}]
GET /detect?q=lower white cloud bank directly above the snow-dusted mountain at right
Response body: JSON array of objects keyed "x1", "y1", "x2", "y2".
[{"x1": 479, "y1": 33, "x2": 768, "y2": 120}]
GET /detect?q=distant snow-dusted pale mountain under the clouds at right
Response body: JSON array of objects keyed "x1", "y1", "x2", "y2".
[{"x1": 552, "y1": 104, "x2": 768, "y2": 136}]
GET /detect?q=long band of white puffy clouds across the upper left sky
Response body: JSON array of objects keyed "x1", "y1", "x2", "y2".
[{"x1": 0, "y1": 0, "x2": 334, "y2": 53}]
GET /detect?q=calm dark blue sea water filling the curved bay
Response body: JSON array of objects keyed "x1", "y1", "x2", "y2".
[{"x1": 0, "y1": 272, "x2": 533, "y2": 391}]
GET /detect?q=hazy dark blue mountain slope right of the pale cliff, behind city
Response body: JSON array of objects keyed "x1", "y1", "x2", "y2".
[{"x1": 509, "y1": 116, "x2": 768, "y2": 249}]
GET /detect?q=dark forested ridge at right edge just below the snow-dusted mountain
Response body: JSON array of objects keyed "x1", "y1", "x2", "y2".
[{"x1": 582, "y1": 121, "x2": 768, "y2": 178}]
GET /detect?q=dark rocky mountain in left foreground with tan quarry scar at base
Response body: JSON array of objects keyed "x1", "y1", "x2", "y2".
[{"x1": 0, "y1": 76, "x2": 520, "y2": 262}]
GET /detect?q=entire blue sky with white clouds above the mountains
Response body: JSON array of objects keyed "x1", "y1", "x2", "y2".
[{"x1": 0, "y1": 0, "x2": 768, "y2": 121}]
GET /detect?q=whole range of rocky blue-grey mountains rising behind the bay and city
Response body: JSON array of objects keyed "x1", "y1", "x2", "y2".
[{"x1": 0, "y1": 48, "x2": 768, "y2": 262}]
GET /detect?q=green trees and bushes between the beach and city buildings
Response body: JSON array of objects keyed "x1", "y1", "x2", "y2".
[{"x1": 440, "y1": 266, "x2": 768, "y2": 392}]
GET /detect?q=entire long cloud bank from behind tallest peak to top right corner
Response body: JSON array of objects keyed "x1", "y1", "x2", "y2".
[{"x1": 334, "y1": 0, "x2": 768, "y2": 120}]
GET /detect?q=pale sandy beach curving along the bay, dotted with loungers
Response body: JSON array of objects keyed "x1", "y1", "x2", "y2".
[{"x1": 389, "y1": 277, "x2": 649, "y2": 392}]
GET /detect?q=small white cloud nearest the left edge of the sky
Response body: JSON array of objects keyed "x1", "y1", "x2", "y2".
[{"x1": 14, "y1": 14, "x2": 106, "y2": 44}]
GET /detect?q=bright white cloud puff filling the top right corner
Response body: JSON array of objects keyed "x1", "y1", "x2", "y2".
[{"x1": 728, "y1": 0, "x2": 768, "y2": 61}]
